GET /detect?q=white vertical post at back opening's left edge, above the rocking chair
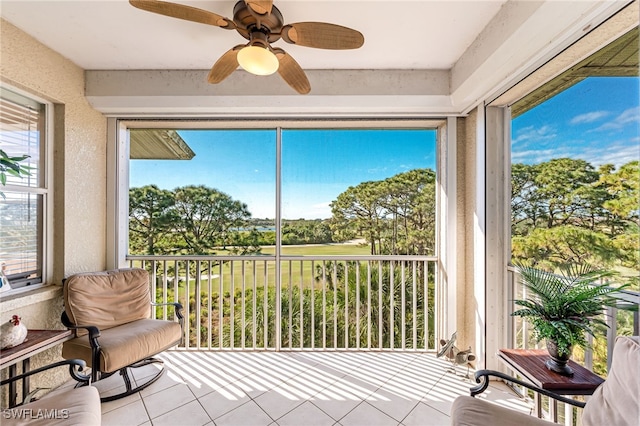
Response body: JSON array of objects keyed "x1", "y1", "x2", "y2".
[{"x1": 106, "y1": 118, "x2": 129, "y2": 269}]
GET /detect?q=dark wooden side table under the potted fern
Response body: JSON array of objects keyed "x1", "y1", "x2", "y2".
[{"x1": 498, "y1": 349, "x2": 604, "y2": 422}]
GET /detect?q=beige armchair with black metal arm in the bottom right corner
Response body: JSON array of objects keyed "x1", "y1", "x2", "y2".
[{"x1": 451, "y1": 336, "x2": 640, "y2": 426}]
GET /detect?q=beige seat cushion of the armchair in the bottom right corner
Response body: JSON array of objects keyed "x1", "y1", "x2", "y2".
[{"x1": 451, "y1": 396, "x2": 557, "y2": 426}]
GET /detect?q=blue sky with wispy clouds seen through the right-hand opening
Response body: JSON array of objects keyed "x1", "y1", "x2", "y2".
[{"x1": 511, "y1": 77, "x2": 640, "y2": 167}]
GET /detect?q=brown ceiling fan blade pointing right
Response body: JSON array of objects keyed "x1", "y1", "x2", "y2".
[{"x1": 281, "y1": 22, "x2": 364, "y2": 50}]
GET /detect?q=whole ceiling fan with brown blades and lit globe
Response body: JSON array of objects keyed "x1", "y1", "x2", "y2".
[{"x1": 129, "y1": 0, "x2": 364, "y2": 94}]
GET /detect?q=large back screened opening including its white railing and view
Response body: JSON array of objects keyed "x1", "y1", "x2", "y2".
[{"x1": 119, "y1": 120, "x2": 444, "y2": 350}]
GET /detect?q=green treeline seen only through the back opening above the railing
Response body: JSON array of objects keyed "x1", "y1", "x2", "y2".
[{"x1": 129, "y1": 169, "x2": 435, "y2": 255}]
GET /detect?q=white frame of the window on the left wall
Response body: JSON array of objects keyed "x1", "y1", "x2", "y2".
[{"x1": 0, "y1": 84, "x2": 54, "y2": 296}]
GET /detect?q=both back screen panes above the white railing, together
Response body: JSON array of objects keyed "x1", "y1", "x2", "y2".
[{"x1": 129, "y1": 128, "x2": 436, "y2": 256}]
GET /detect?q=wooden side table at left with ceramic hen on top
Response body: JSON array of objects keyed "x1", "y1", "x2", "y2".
[{"x1": 0, "y1": 330, "x2": 72, "y2": 407}]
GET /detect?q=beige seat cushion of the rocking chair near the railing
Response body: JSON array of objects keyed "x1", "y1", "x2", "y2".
[{"x1": 62, "y1": 319, "x2": 182, "y2": 373}]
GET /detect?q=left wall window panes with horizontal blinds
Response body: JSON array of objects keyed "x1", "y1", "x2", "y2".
[{"x1": 0, "y1": 88, "x2": 49, "y2": 290}]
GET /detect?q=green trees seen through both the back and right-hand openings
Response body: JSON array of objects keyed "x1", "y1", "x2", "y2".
[{"x1": 129, "y1": 158, "x2": 640, "y2": 286}]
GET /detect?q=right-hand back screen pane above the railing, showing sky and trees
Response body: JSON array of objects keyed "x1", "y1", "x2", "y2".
[{"x1": 282, "y1": 128, "x2": 436, "y2": 256}]
